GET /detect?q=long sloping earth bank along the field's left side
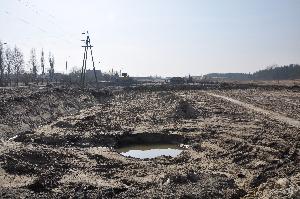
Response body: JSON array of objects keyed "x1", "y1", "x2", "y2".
[{"x1": 0, "y1": 88, "x2": 112, "y2": 140}]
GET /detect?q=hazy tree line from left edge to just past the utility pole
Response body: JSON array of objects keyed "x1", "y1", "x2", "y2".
[{"x1": 0, "y1": 41, "x2": 130, "y2": 87}]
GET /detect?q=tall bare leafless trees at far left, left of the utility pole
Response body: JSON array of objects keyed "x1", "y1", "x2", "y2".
[{"x1": 0, "y1": 41, "x2": 55, "y2": 87}]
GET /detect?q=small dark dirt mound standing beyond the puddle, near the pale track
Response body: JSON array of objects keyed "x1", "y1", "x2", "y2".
[{"x1": 174, "y1": 100, "x2": 199, "y2": 119}]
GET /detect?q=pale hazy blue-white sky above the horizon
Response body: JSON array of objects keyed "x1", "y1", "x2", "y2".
[{"x1": 0, "y1": 0, "x2": 300, "y2": 76}]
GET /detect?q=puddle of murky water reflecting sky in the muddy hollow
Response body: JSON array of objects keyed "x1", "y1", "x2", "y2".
[{"x1": 116, "y1": 144, "x2": 182, "y2": 159}]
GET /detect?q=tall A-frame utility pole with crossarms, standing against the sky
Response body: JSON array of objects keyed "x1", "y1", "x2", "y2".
[{"x1": 80, "y1": 31, "x2": 98, "y2": 87}]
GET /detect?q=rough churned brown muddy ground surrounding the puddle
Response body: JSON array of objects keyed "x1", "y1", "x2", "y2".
[{"x1": 0, "y1": 84, "x2": 300, "y2": 198}]
